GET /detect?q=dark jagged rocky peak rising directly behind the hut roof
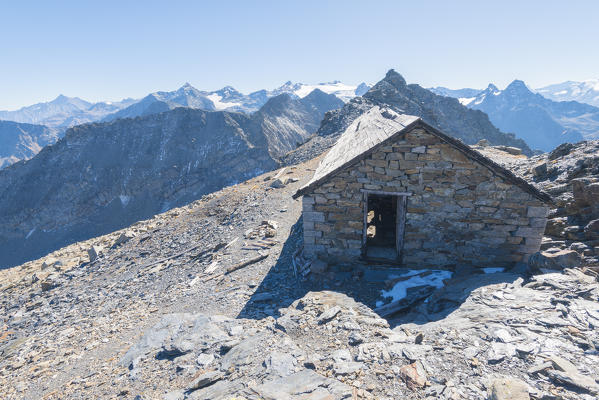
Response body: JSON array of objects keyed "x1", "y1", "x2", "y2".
[{"x1": 318, "y1": 70, "x2": 531, "y2": 154}]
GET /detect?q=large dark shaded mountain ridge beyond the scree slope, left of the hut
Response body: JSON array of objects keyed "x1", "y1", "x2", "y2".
[{"x1": 0, "y1": 90, "x2": 343, "y2": 267}]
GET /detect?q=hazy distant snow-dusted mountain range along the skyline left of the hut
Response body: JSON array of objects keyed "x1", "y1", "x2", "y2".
[{"x1": 0, "y1": 81, "x2": 370, "y2": 169}]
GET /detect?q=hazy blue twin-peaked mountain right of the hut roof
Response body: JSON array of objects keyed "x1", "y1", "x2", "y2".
[{"x1": 468, "y1": 80, "x2": 599, "y2": 151}]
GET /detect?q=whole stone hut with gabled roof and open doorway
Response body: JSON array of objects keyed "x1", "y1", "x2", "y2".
[{"x1": 294, "y1": 107, "x2": 551, "y2": 267}]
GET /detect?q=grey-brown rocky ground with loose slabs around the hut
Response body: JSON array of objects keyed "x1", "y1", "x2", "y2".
[{"x1": 0, "y1": 142, "x2": 599, "y2": 400}]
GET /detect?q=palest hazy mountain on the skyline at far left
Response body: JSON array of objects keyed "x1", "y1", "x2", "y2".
[{"x1": 0, "y1": 94, "x2": 137, "y2": 129}]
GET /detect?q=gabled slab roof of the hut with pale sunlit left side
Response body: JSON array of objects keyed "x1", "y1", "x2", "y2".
[{"x1": 293, "y1": 106, "x2": 552, "y2": 203}]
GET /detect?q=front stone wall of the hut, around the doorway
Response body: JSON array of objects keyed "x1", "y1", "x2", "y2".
[{"x1": 303, "y1": 129, "x2": 548, "y2": 267}]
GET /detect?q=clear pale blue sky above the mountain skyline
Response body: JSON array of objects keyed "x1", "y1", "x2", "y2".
[{"x1": 0, "y1": 0, "x2": 599, "y2": 109}]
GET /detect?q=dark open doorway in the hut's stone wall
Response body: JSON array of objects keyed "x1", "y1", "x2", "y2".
[{"x1": 366, "y1": 194, "x2": 398, "y2": 260}]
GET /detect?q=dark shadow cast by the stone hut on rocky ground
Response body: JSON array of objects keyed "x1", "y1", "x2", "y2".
[{"x1": 237, "y1": 218, "x2": 524, "y2": 328}]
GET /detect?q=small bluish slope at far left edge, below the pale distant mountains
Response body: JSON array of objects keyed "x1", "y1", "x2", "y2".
[{"x1": 0, "y1": 121, "x2": 58, "y2": 169}]
